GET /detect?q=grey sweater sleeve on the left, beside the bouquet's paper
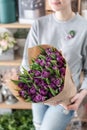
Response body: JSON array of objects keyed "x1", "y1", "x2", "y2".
[{"x1": 20, "y1": 21, "x2": 38, "y2": 72}]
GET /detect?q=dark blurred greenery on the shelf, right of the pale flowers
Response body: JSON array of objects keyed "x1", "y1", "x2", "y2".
[{"x1": 14, "y1": 29, "x2": 29, "y2": 39}]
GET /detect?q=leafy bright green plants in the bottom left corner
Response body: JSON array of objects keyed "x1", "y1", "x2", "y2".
[{"x1": 0, "y1": 110, "x2": 34, "y2": 130}]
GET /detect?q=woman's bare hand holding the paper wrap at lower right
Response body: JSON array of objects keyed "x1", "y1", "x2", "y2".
[{"x1": 67, "y1": 90, "x2": 87, "y2": 110}]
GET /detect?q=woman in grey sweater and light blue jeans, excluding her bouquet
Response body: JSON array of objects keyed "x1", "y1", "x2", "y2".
[{"x1": 22, "y1": 0, "x2": 87, "y2": 130}]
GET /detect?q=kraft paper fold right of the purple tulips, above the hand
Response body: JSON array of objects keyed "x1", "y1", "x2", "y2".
[{"x1": 44, "y1": 65, "x2": 76, "y2": 105}]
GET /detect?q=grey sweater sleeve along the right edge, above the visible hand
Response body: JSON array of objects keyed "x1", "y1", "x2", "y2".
[{"x1": 80, "y1": 37, "x2": 87, "y2": 89}]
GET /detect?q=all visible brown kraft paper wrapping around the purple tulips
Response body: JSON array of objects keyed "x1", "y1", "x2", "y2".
[{"x1": 7, "y1": 44, "x2": 76, "y2": 105}]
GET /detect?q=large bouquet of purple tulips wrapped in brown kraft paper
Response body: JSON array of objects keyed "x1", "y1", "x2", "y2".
[{"x1": 11, "y1": 45, "x2": 76, "y2": 104}]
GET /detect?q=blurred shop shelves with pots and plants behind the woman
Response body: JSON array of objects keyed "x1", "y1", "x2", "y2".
[{"x1": 0, "y1": 0, "x2": 87, "y2": 130}]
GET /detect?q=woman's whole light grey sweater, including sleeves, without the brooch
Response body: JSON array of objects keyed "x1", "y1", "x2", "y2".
[{"x1": 21, "y1": 13, "x2": 87, "y2": 89}]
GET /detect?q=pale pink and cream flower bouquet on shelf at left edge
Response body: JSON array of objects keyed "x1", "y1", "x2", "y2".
[{"x1": 0, "y1": 32, "x2": 16, "y2": 54}]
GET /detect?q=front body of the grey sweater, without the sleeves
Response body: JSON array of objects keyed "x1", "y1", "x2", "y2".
[{"x1": 32, "y1": 14, "x2": 87, "y2": 86}]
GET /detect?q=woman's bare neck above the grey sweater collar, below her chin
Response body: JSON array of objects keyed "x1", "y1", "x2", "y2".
[{"x1": 55, "y1": 9, "x2": 75, "y2": 21}]
